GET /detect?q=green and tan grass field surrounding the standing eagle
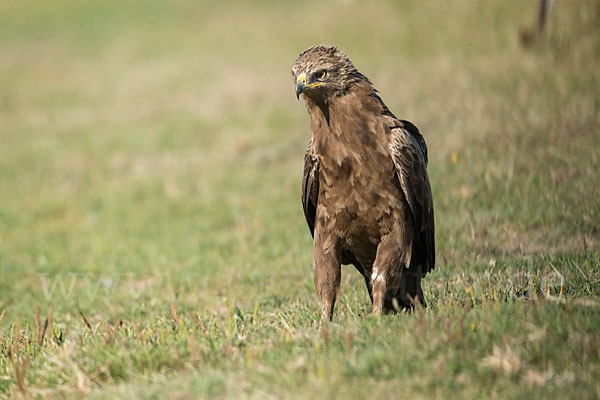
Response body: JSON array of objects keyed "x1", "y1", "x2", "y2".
[{"x1": 0, "y1": 0, "x2": 600, "y2": 399}]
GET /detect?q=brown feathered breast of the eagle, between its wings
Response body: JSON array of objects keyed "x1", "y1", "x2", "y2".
[{"x1": 311, "y1": 92, "x2": 404, "y2": 247}]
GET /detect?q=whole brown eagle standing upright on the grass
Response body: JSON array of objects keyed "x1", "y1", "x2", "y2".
[{"x1": 292, "y1": 45, "x2": 435, "y2": 320}]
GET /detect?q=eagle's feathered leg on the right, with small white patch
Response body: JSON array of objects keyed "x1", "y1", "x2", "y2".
[{"x1": 371, "y1": 232, "x2": 411, "y2": 315}]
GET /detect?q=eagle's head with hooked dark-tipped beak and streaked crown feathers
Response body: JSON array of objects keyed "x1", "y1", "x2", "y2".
[{"x1": 292, "y1": 45, "x2": 366, "y2": 99}]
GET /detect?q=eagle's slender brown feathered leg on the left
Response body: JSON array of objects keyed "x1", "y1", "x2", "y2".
[{"x1": 313, "y1": 229, "x2": 342, "y2": 322}]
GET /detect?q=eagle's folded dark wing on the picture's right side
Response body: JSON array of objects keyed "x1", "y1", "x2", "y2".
[{"x1": 389, "y1": 119, "x2": 435, "y2": 274}]
